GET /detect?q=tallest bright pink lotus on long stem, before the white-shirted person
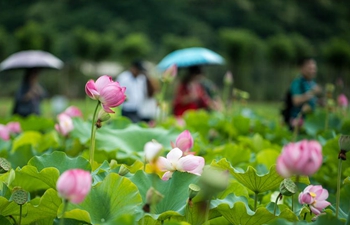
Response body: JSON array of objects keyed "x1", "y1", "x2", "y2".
[{"x1": 85, "y1": 75, "x2": 126, "y2": 113}]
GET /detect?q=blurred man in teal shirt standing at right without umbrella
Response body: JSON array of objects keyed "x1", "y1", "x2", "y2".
[{"x1": 288, "y1": 57, "x2": 322, "y2": 129}]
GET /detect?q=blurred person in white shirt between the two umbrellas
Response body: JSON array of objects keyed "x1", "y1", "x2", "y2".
[{"x1": 117, "y1": 60, "x2": 156, "y2": 123}]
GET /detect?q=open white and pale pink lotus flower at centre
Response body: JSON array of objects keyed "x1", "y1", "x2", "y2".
[{"x1": 157, "y1": 148, "x2": 205, "y2": 180}]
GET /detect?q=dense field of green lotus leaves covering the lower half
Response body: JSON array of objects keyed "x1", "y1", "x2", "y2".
[{"x1": 0, "y1": 95, "x2": 350, "y2": 225}]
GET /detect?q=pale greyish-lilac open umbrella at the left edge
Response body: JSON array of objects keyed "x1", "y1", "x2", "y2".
[{"x1": 0, "y1": 50, "x2": 64, "y2": 71}]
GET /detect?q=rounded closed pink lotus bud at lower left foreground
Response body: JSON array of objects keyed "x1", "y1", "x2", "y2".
[{"x1": 56, "y1": 169, "x2": 92, "y2": 204}]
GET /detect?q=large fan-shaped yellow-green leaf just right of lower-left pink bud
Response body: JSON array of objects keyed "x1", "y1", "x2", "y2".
[{"x1": 63, "y1": 173, "x2": 142, "y2": 224}]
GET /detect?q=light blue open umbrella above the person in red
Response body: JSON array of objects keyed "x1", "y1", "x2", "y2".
[{"x1": 157, "y1": 47, "x2": 225, "y2": 71}]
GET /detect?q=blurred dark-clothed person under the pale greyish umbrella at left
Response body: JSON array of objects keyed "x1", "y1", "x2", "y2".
[{"x1": 13, "y1": 68, "x2": 46, "y2": 117}]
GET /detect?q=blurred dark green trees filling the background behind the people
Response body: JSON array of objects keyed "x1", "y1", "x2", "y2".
[{"x1": 0, "y1": 0, "x2": 350, "y2": 101}]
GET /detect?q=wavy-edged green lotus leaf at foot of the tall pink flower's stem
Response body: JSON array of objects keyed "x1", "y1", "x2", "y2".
[{"x1": 28, "y1": 151, "x2": 91, "y2": 174}]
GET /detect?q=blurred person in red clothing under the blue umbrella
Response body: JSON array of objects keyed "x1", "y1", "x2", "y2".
[{"x1": 173, "y1": 66, "x2": 219, "y2": 116}]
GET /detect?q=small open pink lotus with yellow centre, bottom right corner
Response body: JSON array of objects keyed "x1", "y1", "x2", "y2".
[{"x1": 299, "y1": 185, "x2": 331, "y2": 216}]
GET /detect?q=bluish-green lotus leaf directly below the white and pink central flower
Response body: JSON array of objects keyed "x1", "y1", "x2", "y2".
[{"x1": 130, "y1": 170, "x2": 199, "y2": 220}]
